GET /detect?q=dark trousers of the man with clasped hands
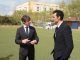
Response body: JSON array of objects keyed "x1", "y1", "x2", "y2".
[{"x1": 19, "y1": 47, "x2": 35, "y2": 60}]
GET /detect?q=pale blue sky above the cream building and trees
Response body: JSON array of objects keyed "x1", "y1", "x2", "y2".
[{"x1": 0, "y1": 0, "x2": 69, "y2": 15}]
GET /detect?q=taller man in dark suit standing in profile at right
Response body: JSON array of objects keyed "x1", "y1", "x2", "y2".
[{"x1": 52, "y1": 10, "x2": 73, "y2": 60}]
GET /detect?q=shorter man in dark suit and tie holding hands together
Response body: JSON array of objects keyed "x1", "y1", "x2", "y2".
[{"x1": 15, "y1": 15, "x2": 39, "y2": 60}]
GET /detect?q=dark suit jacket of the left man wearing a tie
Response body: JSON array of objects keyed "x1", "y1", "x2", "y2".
[{"x1": 15, "y1": 26, "x2": 39, "y2": 47}]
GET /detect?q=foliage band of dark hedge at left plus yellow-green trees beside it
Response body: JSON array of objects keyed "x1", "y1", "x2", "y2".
[{"x1": 0, "y1": 11, "x2": 51, "y2": 25}]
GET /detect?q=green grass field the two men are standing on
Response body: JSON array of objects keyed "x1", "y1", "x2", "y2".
[{"x1": 0, "y1": 26, "x2": 80, "y2": 60}]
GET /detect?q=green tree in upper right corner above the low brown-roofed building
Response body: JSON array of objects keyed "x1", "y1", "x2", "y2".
[{"x1": 68, "y1": 0, "x2": 80, "y2": 17}]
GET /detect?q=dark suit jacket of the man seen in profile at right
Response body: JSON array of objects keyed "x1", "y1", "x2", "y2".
[{"x1": 54, "y1": 22, "x2": 73, "y2": 59}]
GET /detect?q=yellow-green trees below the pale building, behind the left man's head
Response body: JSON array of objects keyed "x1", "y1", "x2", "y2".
[{"x1": 12, "y1": 11, "x2": 50, "y2": 22}]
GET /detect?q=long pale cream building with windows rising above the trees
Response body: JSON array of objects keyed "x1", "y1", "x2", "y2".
[{"x1": 16, "y1": 1, "x2": 60, "y2": 12}]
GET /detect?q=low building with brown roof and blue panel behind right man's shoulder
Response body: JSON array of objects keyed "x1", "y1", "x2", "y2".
[{"x1": 64, "y1": 17, "x2": 80, "y2": 29}]
